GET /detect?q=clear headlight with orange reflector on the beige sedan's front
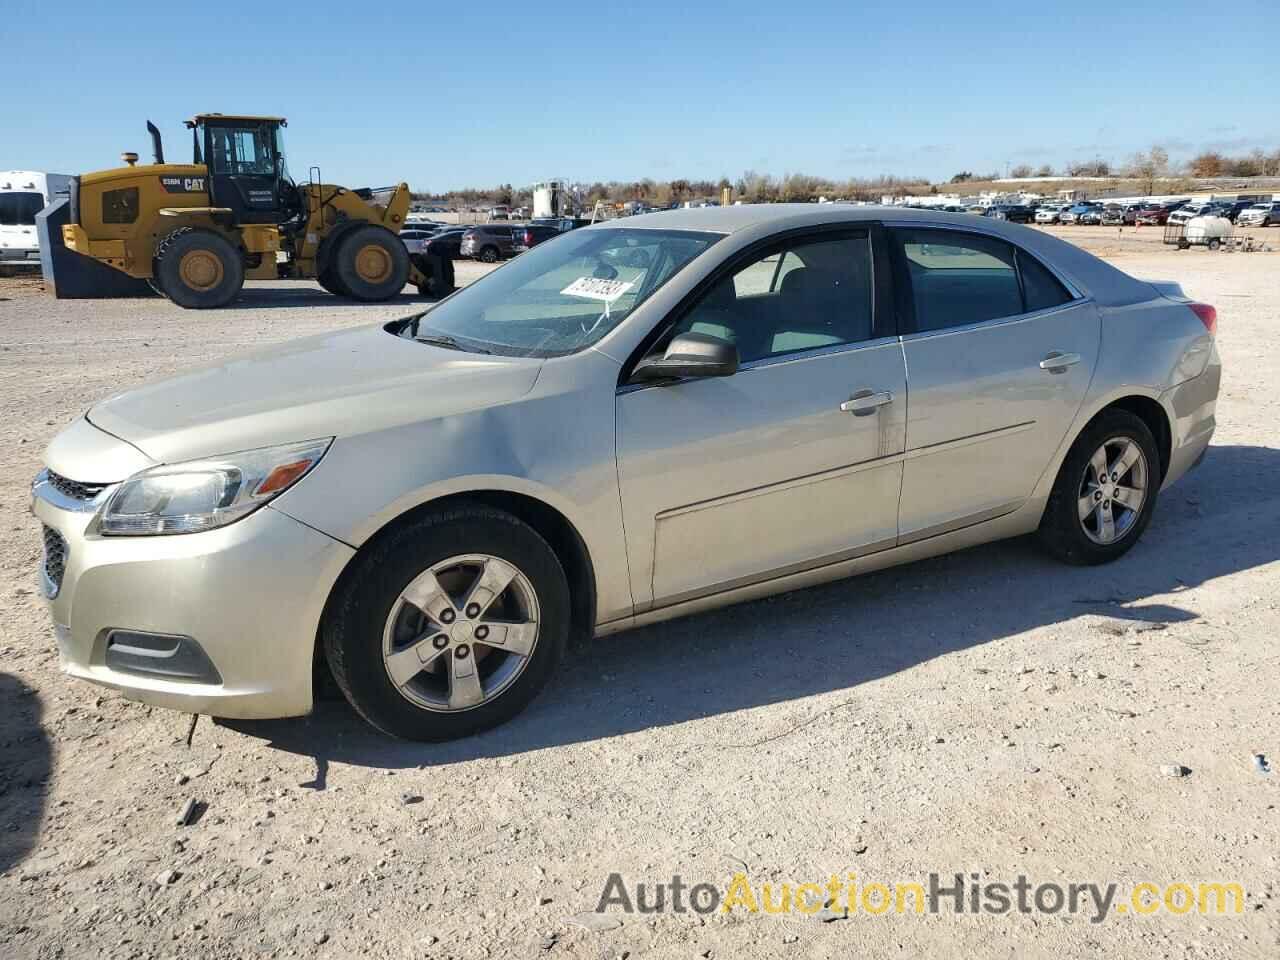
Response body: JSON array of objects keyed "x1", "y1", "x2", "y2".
[{"x1": 99, "y1": 436, "x2": 333, "y2": 536}]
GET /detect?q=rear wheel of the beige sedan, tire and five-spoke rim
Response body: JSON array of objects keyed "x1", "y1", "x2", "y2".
[{"x1": 1039, "y1": 410, "x2": 1164, "y2": 566}]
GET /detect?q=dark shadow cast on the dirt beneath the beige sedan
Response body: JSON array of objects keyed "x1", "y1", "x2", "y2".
[{"x1": 227, "y1": 447, "x2": 1280, "y2": 773}]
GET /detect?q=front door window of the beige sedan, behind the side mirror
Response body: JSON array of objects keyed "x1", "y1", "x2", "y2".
[{"x1": 673, "y1": 233, "x2": 873, "y2": 364}]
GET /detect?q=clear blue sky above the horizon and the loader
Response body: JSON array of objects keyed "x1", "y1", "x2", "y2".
[{"x1": 0, "y1": 0, "x2": 1280, "y2": 189}]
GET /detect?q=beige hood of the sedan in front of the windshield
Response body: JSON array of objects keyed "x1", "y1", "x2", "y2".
[{"x1": 86, "y1": 325, "x2": 543, "y2": 463}]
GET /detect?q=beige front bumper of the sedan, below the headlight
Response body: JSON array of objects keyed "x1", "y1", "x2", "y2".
[{"x1": 32, "y1": 484, "x2": 355, "y2": 719}]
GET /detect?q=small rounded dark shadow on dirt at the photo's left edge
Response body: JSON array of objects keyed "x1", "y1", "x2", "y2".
[{"x1": 0, "y1": 673, "x2": 52, "y2": 876}]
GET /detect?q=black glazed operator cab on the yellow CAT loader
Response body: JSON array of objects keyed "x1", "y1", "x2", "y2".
[{"x1": 187, "y1": 114, "x2": 297, "y2": 224}]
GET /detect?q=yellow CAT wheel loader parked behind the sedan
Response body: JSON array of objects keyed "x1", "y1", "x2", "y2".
[{"x1": 63, "y1": 114, "x2": 448, "y2": 308}]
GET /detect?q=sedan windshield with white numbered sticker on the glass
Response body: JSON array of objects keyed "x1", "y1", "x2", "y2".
[{"x1": 401, "y1": 229, "x2": 719, "y2": 357}]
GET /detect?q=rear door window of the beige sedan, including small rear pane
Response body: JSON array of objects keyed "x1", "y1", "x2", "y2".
[{"x1": 895, "y1": 229, "x2": 1071, "y2": 333}]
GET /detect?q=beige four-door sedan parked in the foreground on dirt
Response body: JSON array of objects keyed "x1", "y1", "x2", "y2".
[{"x1": 32, "y1": 204, "x2": 1221, "y2": 741}]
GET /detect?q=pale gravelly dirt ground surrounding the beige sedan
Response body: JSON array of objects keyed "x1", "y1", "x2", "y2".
[{"x1": 0, "y1": 235, "x2": 1280, "y2": 960}]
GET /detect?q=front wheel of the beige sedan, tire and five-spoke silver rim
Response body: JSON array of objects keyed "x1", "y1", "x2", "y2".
[{"x1": 321, "y1": 504, "x2": 570, "y2": 742}]
